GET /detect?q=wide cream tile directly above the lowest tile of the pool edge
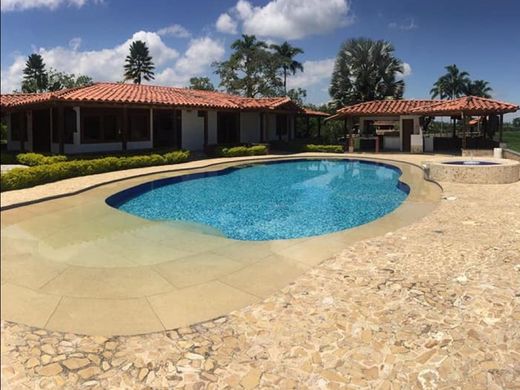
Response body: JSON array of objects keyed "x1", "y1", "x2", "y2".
[{"x1": 41, "y1": 267, "x2": 174, "y2": 299}]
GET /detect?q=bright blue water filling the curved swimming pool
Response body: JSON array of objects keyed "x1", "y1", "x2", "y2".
[{"x1": 107, "y1": 160, "x2": 409, "y2": 241}]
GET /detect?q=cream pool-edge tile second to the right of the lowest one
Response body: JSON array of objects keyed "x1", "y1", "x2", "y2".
[{"x1": 219, "y1": 255, "x2": 308, "y2": 298}]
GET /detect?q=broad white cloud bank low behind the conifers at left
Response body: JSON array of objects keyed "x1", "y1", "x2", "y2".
[{"x1": 1, "y1": 31, "x2": 225, "y2": 92}]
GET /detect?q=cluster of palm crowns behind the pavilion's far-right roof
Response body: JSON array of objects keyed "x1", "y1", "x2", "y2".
[{"x1": 430, "y1": 64, "x2": 492, "y2": 99}]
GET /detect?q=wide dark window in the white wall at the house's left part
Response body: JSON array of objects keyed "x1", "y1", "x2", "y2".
[{"x1": 81, "y1": 109, "x2": 121, "y2": 143}]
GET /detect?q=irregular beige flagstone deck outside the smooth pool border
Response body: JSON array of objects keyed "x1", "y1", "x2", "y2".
[{"x1": 1, "y1": 154, "x2": 520, "y2": 389}]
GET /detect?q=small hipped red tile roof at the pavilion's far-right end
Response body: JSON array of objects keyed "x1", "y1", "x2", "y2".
[{"x1": 412, "y1": 96, "x2": 520, "y2": 115}]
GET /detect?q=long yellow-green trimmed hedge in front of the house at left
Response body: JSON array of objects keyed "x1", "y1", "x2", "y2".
[{"x1": 0, "y1": 150, "x2": 190, "y2": 191}]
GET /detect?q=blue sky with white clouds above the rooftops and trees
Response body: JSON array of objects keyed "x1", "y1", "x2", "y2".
[{"x1": 1, "y1": 0, "x2": 520, "y2": 119}]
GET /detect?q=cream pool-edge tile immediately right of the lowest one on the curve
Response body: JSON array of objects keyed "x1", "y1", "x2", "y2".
[{"x1": 148, "y1": 281, "x2": 258, "y2": 329}]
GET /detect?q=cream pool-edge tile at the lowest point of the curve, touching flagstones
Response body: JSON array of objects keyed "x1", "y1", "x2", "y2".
[{"x1": 46, "y1": 297, "x2": 164, "y2": 336}]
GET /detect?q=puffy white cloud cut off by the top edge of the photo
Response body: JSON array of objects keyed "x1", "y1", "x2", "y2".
[{"x1": 217, "y1": 0, "x2": 352, "y2": 39}]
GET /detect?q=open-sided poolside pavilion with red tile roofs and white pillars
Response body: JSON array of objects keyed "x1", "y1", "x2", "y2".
[{"x1": 327, "y1": 96, "x2": 520, "y2": 153}]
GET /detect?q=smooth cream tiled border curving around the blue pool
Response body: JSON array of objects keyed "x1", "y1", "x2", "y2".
[{"x1": 2, "y1": 154, "x2": 442, "y2": 335}]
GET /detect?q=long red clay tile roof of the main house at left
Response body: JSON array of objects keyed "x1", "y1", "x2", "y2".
[{"x1": 0, "y1": 83, "x2": 302, "y2": 111}]
